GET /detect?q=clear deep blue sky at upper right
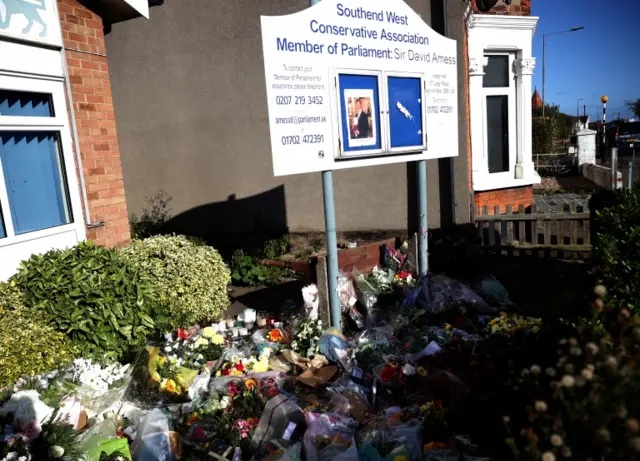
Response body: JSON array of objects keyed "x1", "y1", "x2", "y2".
[{"x1": 531, "y1": 0, "x2": 640, "y2": 120}]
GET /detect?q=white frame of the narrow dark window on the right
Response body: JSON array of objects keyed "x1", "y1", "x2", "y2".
[{"x1": 482, "y1": 52, "x2": 517, "y2": 181}]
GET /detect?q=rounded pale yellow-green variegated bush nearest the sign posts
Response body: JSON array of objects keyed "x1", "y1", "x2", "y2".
[{"x1": 122, "y1": 236, "x2": 231, "y2": 328}]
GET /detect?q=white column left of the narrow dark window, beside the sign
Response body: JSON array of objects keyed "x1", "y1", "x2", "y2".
[{"x1": 469, "y1": 55, "x2": 489, "y2": 179}]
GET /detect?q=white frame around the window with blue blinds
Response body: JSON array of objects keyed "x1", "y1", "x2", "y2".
[{"x1": 0, "y1": 72, "x2": 86, "y2": 248}]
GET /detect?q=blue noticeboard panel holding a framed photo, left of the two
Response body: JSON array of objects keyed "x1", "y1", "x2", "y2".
[{"x1": 338, "y1": 74, "x2": 382, "y2": 152}]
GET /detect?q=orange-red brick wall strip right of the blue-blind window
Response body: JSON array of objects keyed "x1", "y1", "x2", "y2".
[{"x1": 58, "y1": 0, "x2": 131, "y2": 246}]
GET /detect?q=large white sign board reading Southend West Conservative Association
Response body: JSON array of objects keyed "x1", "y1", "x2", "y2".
[{"x1": 261, "y1": 0, "x2": 458, "y2": 176}]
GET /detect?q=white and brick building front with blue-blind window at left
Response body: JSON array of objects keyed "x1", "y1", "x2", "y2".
[{"x1": 0, "y1": 0, "x2": 149, "y2": 280}]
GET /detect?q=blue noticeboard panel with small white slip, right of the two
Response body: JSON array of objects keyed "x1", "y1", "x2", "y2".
[{"x1": 387, "y1": 77, "x2": 425, "y2": 150}]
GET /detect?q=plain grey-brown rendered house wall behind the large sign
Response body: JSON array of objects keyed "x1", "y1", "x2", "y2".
[{"x1": 107, "y1": 0, "x2": 472, "y2": 252}]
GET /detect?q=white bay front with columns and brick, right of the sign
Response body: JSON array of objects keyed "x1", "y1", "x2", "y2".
[{"x1": 465, "y1": 0, "x2": 540, "y2": 214}]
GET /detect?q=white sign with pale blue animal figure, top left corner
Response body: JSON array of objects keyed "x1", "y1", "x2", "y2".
[{"x1": 0, "y1": 0, "x2": 62, "y2": 47}]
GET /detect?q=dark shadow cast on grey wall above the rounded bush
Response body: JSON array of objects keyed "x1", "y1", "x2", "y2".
[{"x1": 162, "y1": 186, "x2": 287, "y2": 258}]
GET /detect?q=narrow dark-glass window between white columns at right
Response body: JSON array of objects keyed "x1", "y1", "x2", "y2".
[{"x1": 482, "y1": 54, "x2": 516, "y2": 174}]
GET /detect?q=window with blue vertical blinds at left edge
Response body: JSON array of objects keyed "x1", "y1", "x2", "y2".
[{"x1": 0, "y1": 76, "x2": 75, "y2": 246}]
